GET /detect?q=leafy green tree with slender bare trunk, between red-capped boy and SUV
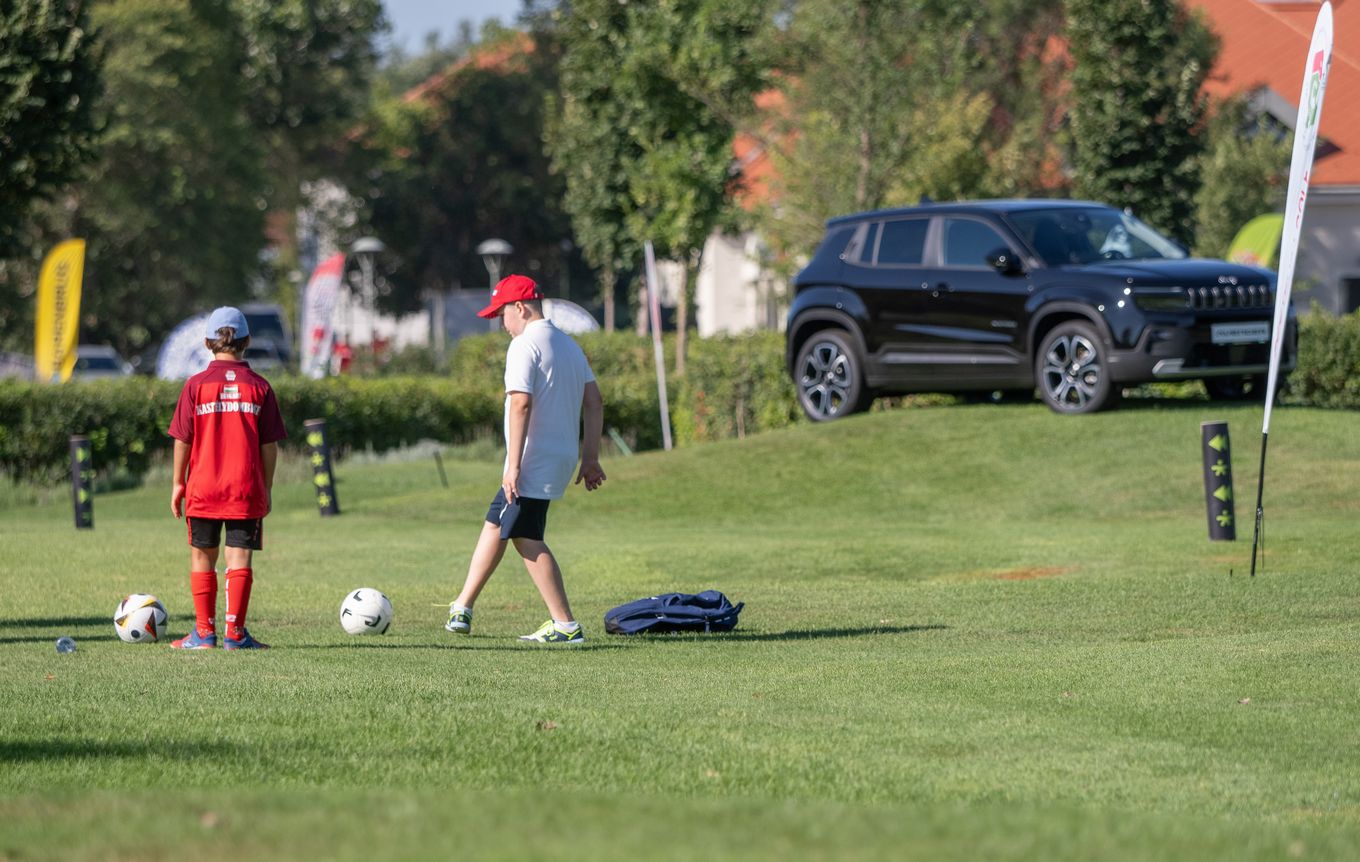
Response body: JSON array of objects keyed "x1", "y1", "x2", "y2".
[{"x1": 551, "y1": 0, "x2": 772, "y2": 361}]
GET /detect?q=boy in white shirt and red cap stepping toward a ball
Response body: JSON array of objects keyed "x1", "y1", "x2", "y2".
[{"x1": 445, "y1": 275, "x2": 605, "y2": 644}]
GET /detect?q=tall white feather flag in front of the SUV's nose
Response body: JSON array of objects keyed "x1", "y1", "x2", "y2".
[{"x1": 1261, "y1": 3, "x2": 1331, "y2": 434}]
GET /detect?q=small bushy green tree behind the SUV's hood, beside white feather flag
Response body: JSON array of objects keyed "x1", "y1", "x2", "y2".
[{"x1": 1194, "y1": 98, "x2": 1293, "y2": 257}]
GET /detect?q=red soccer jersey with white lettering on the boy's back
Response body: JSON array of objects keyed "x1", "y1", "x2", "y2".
[{"x1": 170, "y1": 359, "x2": 288, "y2": 521}]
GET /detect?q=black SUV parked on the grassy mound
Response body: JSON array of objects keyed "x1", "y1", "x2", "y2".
[{"x1": 787, "y1": 200, "x2": 1297, "y2": 421}]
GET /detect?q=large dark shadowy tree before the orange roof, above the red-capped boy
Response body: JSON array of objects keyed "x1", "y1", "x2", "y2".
[{"x1": 344, "y1": 29, "x2": 571, "y2": 315}]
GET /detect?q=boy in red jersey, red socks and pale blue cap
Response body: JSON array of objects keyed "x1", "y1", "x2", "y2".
[{"x1": 170, "y1": 306, "x2": 287, "y2": 650}]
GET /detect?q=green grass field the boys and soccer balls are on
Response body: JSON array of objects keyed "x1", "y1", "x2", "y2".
[{"x1": 0, "y1": 401, "x2": 1360, "y2": 861}]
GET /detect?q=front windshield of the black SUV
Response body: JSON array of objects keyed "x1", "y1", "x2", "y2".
[{"x1": 1009, "y1": 207, "x2": 1186, "y2": 266}]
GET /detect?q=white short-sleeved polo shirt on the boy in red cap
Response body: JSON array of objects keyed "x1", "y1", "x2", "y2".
[{"x1": 505, "y1": 320, "x2": 594, "y2": 500}]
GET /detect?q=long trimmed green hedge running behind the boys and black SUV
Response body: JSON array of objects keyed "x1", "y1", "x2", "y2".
[{"x1": 0, "y1": 313, "x2": 1360, "y2": 481}]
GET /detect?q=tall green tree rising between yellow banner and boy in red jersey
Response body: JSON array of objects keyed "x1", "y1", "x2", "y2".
[{"x1": 68, "y1": 0, "x2": 267, "y2": 354}]
